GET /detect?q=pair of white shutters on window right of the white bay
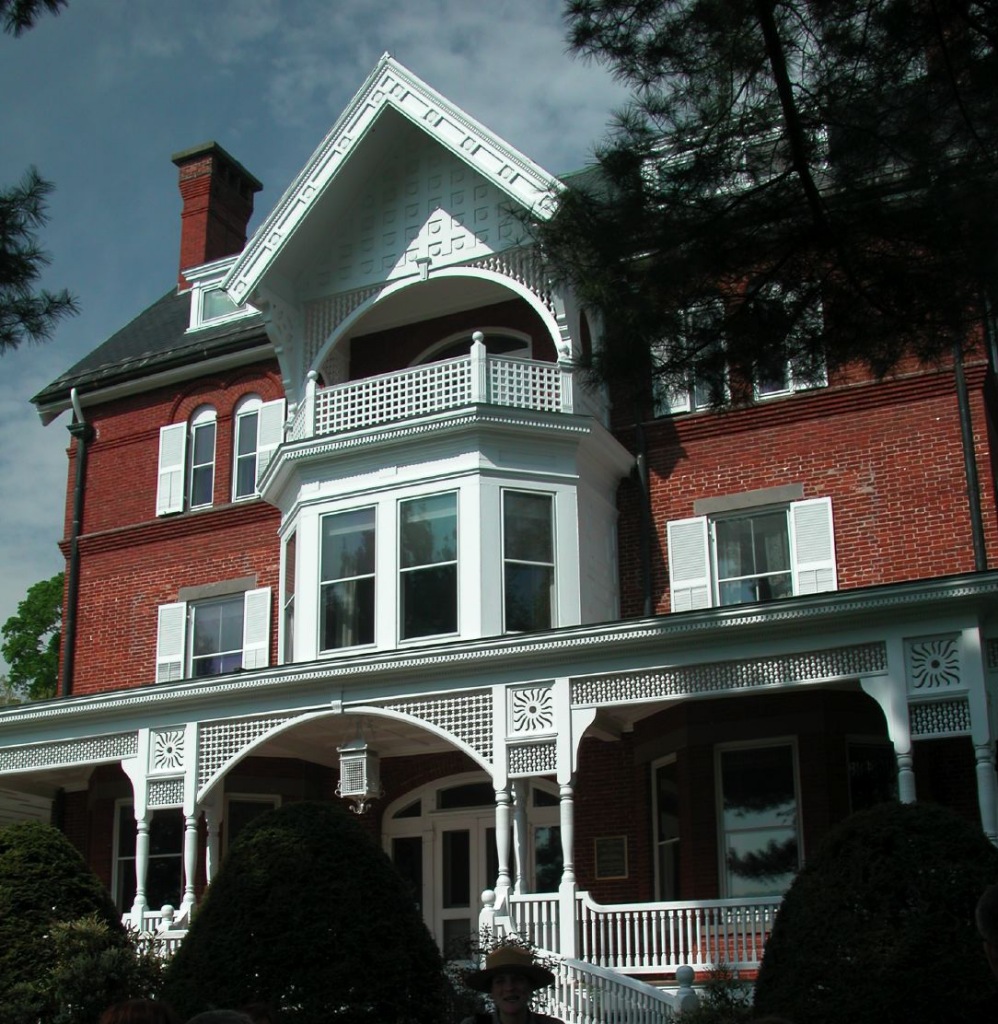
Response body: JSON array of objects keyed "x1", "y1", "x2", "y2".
[{"x1": 665, "y1": 498, "x2": 838, "y2": 611}]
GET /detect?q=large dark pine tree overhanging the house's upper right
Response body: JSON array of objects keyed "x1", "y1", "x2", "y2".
[{"x1": 533, "y1": 0, "x2": 998, "y2": 402}]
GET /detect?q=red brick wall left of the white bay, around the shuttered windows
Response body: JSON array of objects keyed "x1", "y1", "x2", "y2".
[{"x1": 60, "y1": 364, "x2": 281, "y2": 694}]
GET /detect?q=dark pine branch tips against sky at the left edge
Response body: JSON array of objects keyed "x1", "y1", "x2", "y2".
[{"x1": 0, "y1": 0, "x2": 78, "y2": 354}]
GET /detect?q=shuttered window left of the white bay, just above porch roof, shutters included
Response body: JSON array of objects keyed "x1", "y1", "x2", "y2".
[{"x1": 156, "y1": 587, "x2": 270, "y2": 683}]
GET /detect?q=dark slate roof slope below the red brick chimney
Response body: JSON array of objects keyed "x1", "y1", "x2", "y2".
[{"x1": 32, "y1": 288, "x2": 267, "y2": 409}]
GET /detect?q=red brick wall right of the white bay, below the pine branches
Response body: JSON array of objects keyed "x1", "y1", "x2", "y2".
[{"x1": 619, "y1": 367, "x2": 998, "y2": 615}]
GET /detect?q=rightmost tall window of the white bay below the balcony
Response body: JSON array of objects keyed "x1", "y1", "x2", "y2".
[{"x1": 503, "y1": 490, "x2": 555, "y2": 633}]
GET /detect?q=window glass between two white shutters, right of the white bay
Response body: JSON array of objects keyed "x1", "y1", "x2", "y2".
[{"x1": 713, "y1": 509, "x2": 793, "y2": 605}]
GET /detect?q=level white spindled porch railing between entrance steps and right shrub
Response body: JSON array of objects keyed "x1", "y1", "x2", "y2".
[{"x1": 507, "y1": 892, "x2": 781, "y2": 975}]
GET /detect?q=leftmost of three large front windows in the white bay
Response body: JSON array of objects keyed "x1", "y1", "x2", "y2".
[{"x1": 319, "y1": 507, "x2": 376, "y2": 650}]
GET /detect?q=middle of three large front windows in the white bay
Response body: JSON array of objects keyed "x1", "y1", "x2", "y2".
[{"x1": 398, "y1": 492, "x2": 458, "y2": 640}]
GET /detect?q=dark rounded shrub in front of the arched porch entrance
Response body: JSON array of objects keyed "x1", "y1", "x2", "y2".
[{"x1": 164, "y1": 803, "x2": 445, "y2": 1024}]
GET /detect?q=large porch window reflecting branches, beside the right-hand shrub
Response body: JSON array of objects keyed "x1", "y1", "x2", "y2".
[{"x1": 721, "y1": 744, "x2": 799, "y2": 897}]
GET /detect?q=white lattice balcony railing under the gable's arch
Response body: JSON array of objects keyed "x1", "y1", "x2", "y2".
[{"x1": 288, "y1": 341, "x2": 606, "y2": 441}]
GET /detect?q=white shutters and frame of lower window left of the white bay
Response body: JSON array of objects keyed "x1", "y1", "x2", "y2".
[{"x1": 156, "y1": 587, "x2": 270, "y2": 683}]
